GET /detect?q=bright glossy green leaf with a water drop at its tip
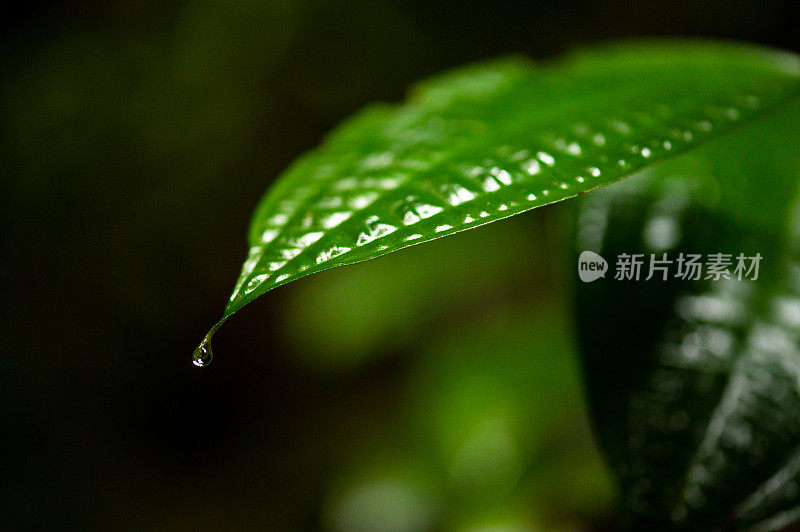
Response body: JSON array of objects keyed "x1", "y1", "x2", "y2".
[{"x1": 196, "y1": 41, "x2": 800, "y2": 360}]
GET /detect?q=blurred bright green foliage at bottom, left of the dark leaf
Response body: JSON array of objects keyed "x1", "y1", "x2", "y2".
[{"x1": 321, "y1": 284, "x2": 613, "y2": 530}]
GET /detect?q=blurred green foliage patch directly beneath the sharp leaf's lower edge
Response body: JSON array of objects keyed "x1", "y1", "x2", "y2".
[{"x1": 282, "y1": 217, "x2": 552, "y2": 370}]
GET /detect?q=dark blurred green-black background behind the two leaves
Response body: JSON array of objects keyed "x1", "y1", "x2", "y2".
[{"x1": 0, "y1": 0, "x2": 800, "y2": 529}]
